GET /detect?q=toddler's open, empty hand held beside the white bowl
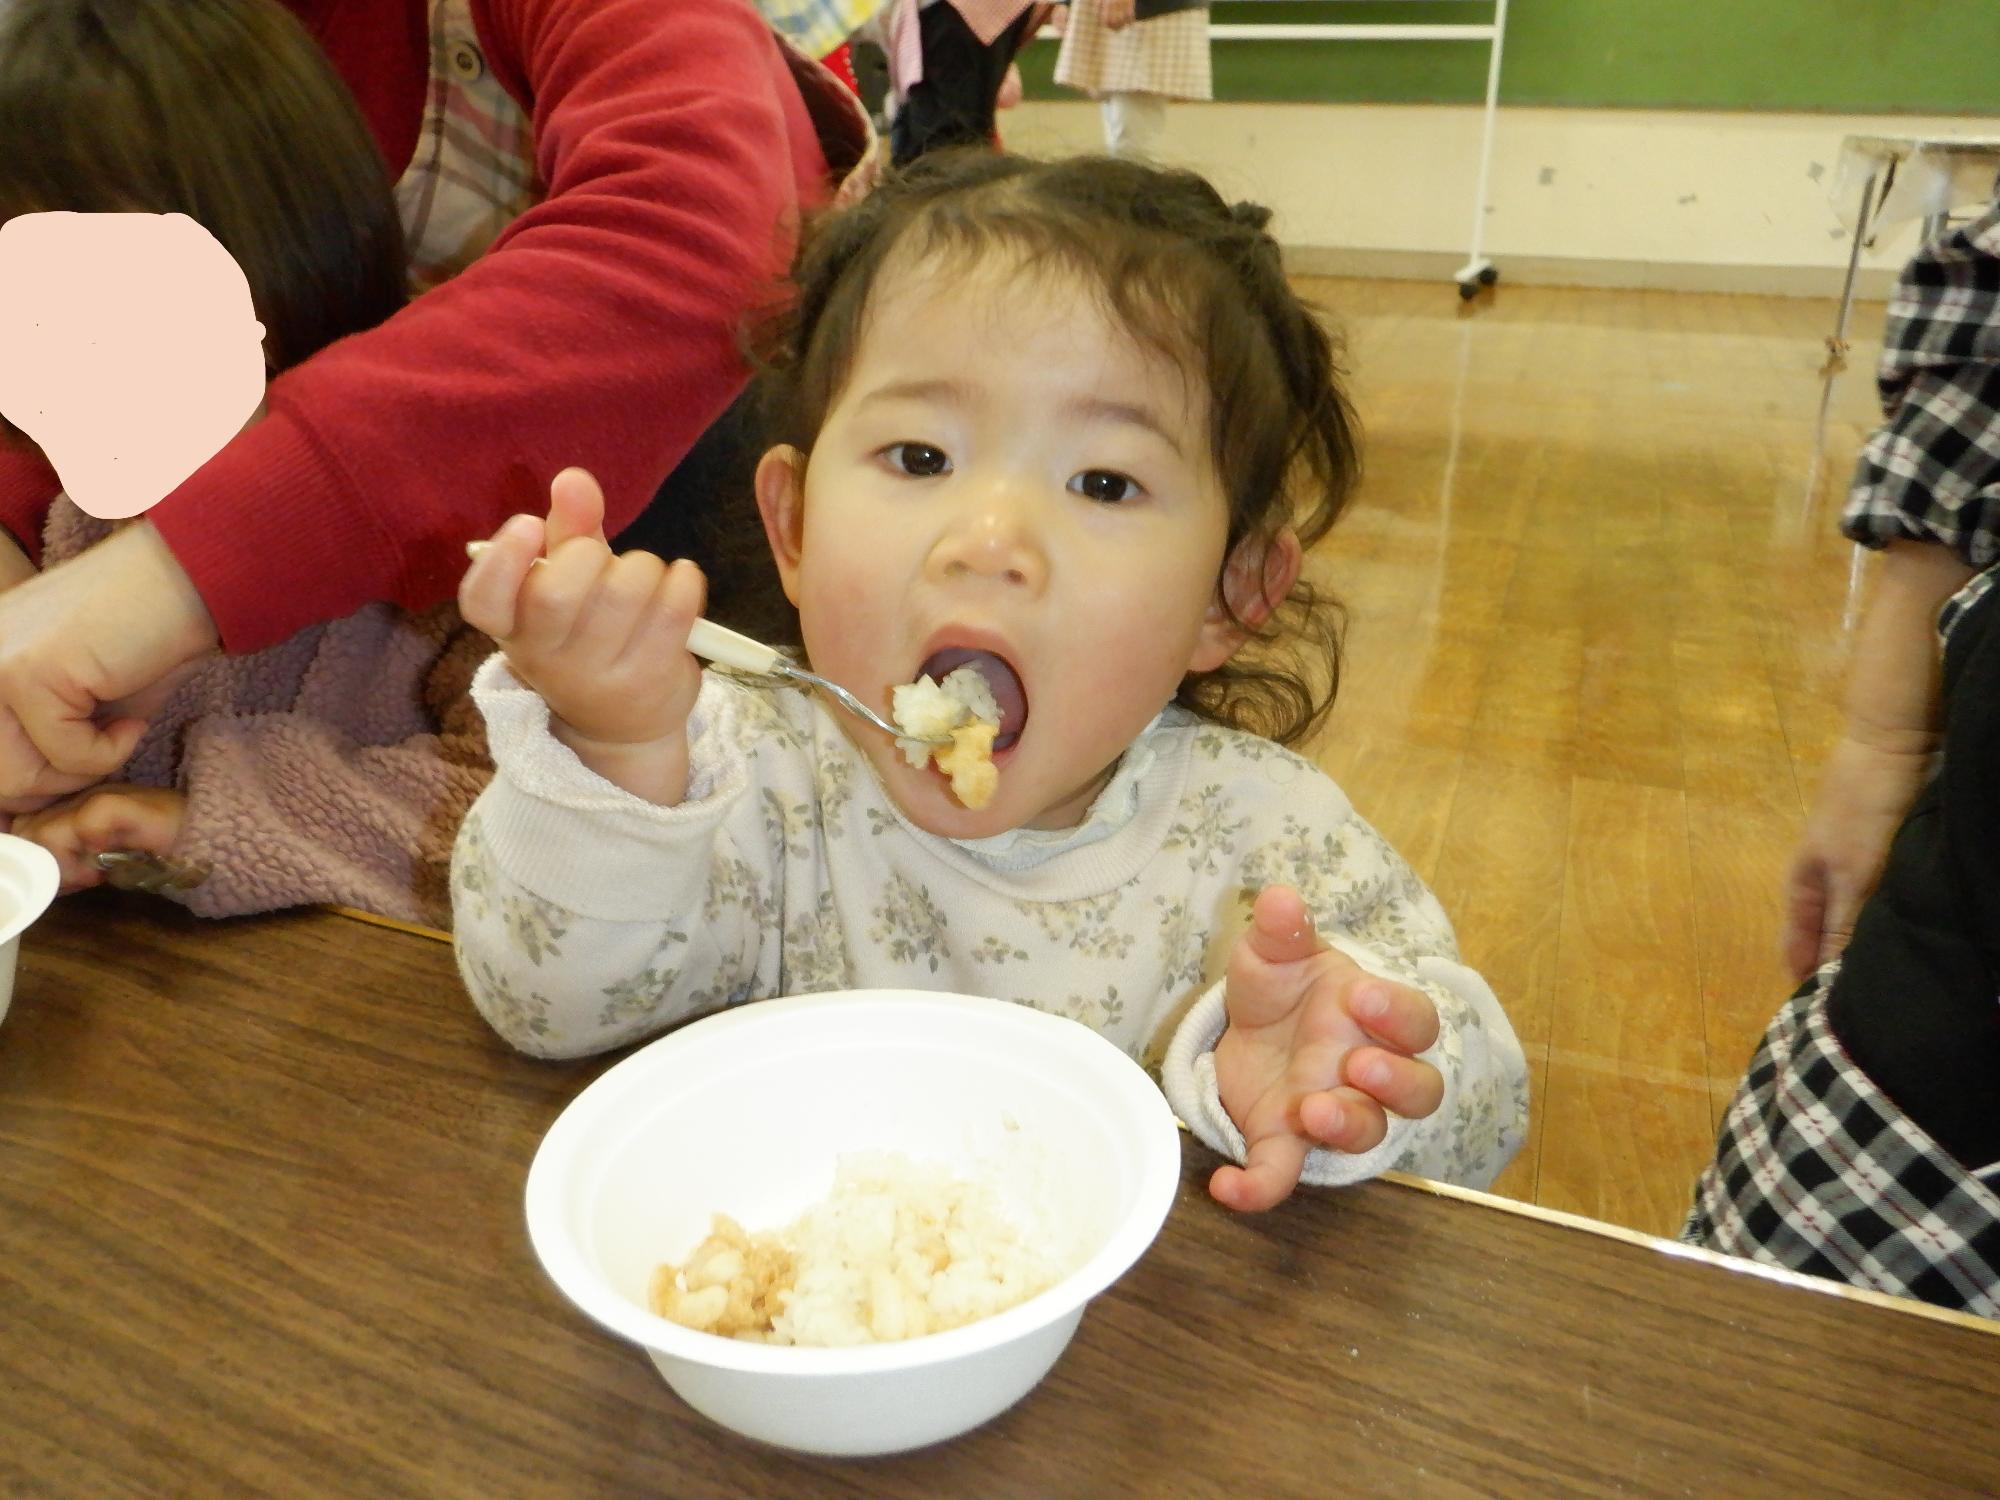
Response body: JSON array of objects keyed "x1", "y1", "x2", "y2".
[{"x1": 1208, "y1": 886, "x2": 1444, "y2": 1210}]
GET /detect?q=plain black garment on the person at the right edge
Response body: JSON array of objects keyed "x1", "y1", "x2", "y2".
[{"x1": 1828, "y1": 576, "x2": 2000, "y2": 1168}]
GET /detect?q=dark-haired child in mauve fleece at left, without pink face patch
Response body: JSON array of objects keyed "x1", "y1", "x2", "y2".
[{"x1": 0, "y1": 0, "x2": 492, "y2": 926}]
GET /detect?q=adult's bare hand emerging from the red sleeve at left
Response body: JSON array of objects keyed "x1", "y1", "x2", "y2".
[{"x1": 0, "y1": 520, "x2": 216, "y2": 812}]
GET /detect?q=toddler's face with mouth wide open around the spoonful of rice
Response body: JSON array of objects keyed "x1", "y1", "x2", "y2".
[{"x1": 758, "y1": 254, "x2": 1238, "y2": 838}]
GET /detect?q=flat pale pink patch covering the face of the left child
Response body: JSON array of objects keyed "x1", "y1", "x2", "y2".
[{"x1": 0, "y1": 214, "x2": 264, "y2": 520}]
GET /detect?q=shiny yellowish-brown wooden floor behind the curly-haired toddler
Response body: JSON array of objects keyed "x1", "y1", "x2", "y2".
[{"x1": 1304, "y1": 280, "x2": 1882, "y2": 1232}]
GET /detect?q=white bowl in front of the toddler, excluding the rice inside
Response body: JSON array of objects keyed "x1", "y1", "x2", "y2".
[{"x1": 528, "y1": 990, "x2": 1180, "y2": 1454}]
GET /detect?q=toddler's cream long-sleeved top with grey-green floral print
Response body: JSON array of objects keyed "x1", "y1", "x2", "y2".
[{"x1": 452, "y1": 656, "x2": 1528, "y2": 1186}]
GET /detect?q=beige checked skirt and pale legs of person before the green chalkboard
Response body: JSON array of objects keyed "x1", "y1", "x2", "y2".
[{"x1": 1056, "y1": 0, "x2": 1214, "y2": 156}]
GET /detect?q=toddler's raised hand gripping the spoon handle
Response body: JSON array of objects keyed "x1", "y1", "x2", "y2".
[{"x1": 458, "y1": 468, "x2": 708, "y2": 776}]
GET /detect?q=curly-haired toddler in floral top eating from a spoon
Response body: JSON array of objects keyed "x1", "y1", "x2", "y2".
[{"x1": 452, "y1": 152, "x2": 1526, "y2": 1208}]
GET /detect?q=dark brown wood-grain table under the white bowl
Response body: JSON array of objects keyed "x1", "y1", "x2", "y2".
[{"x1": 0, "y1": 894, "x2": 2000, "y2": 1500}]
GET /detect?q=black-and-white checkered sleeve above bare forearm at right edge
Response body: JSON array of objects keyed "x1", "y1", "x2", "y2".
[{"x1": 1840, "y1": 206, "x2": 2000, "y2": 568}]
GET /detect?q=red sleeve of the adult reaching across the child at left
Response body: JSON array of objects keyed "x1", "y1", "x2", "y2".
[{"x1": 145, "y1": 0, "x2": 826, "y2": 652}]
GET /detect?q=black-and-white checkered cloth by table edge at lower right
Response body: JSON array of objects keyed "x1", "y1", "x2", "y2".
[{"x1": 1680, "y1": 966, "x2": 2000, "y2": 1318}]
